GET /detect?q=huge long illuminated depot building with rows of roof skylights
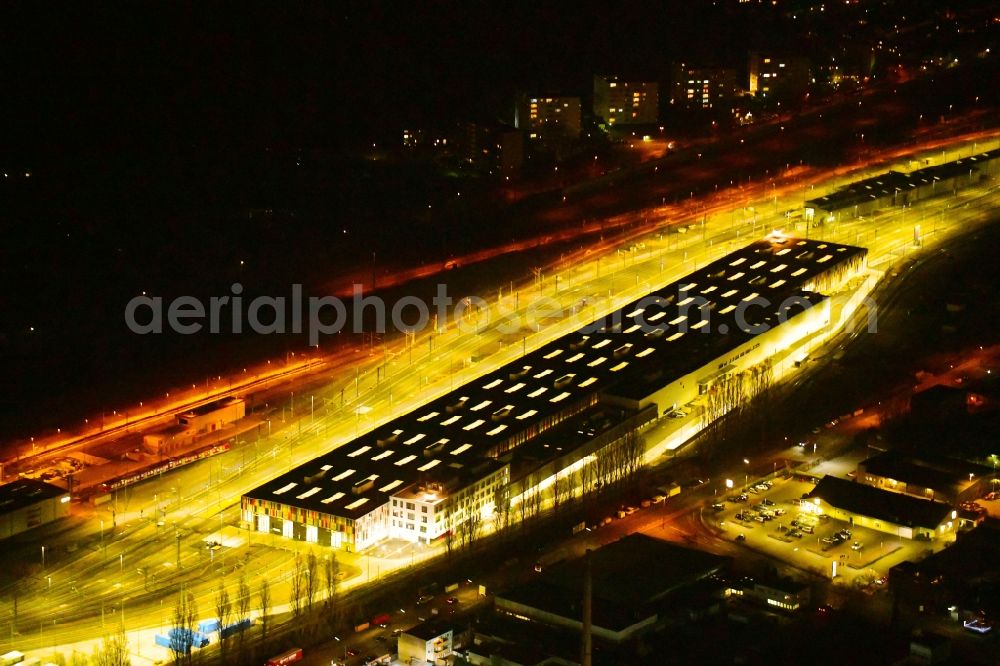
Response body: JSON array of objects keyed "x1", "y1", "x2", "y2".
[{"x1": 242, "y1": 237, "x2": 867, "y2": 550}]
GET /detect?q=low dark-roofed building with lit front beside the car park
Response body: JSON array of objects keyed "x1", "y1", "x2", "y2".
[{"x1": 802, "y1": 476, "x2": 958, "y2": 540}]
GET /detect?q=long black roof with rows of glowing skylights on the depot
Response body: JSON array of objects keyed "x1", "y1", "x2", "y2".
[{"x1": 246, "y1": 238, "x2": 866, "y2": 519}]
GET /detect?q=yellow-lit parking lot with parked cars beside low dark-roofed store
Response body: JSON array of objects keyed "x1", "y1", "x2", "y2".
[{"x1": 703, "y1": 479, "x2": 942, "y2": 584}]
